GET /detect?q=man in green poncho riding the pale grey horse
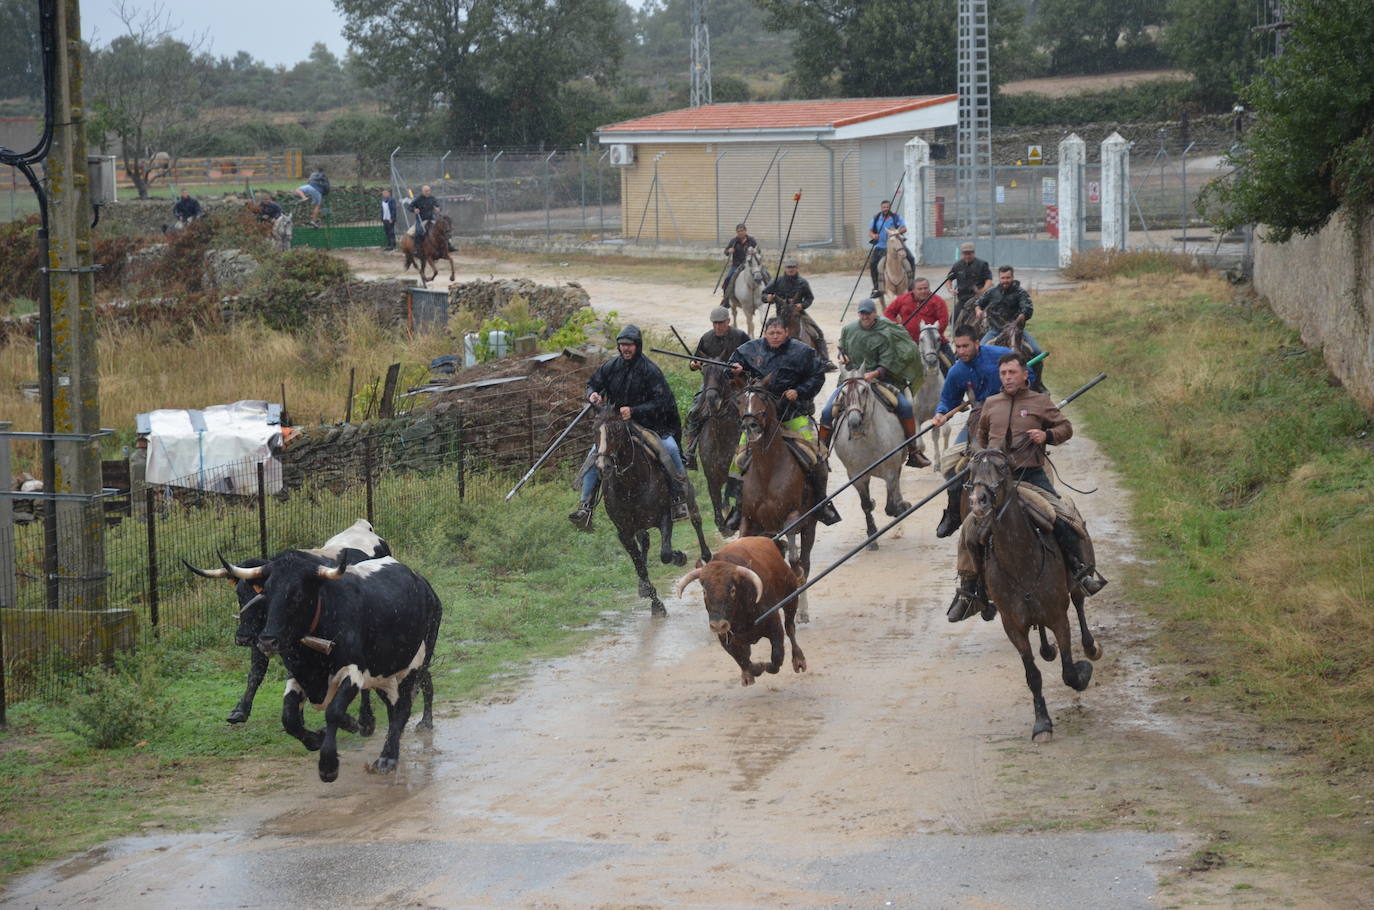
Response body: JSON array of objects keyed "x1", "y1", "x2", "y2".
[{"x1": 820, "y1": 300, "x2": 930, "y2": 467}]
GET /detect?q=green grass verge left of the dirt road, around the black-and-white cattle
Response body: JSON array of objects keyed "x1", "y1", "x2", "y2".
[{"x1": 0, "y1": 476, "x2": 690, "y2": 884}]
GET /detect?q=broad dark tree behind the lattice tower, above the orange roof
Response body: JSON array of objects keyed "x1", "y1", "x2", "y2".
[{"x1": 757, "y1": 0, "x2": 1022, "y2": 98}]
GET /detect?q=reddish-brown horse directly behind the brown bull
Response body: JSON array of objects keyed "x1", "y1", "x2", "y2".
[{"x1": 739, "y1": 377, "x2": 818, "y2": 623}]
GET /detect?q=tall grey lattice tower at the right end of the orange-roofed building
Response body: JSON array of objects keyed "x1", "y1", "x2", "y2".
[{"x1": 955, "y1": 0, "x2": 996, "y2": 238}]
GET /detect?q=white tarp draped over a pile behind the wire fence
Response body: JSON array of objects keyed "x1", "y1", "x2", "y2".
[{"x1": 139, "y1": 401, "x2": 282, "y2": 495}]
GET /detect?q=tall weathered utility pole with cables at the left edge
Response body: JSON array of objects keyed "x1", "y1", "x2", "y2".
[{"x1": 43, "y1": 0, "x2": 106, "y2": 610}]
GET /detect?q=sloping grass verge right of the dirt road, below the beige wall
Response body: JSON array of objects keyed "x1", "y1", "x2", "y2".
[{"x1": 1036, "y1": 271, "x2": 1374, "y2": 843}]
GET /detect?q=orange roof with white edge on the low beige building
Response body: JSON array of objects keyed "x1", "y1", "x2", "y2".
[{"x1": 596, "y1": 95, "x2": 959, "y2": 143}]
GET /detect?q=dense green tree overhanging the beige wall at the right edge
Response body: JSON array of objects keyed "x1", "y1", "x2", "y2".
[{"x1": 1200, "y1": 0, "x2": 1374, "y2": 242}]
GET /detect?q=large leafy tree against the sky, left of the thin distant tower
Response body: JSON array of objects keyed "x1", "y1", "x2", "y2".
[{"x1": 334, "y1": 0, "x2": 621, "y2": 144}]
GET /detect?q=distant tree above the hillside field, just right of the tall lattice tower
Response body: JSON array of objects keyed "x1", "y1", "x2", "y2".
[{"x1": 1032, "y1": 0, "x2": 1167, "y2": 74}]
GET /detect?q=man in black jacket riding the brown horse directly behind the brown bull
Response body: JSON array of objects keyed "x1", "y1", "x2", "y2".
[{"x1": 725, "y1": 316, "x2": 840, "y2": 528}]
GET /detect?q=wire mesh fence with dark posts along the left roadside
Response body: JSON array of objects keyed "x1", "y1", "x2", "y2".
[{"x1": 0, "y1": 392, "x2": 591, "y2": 704}]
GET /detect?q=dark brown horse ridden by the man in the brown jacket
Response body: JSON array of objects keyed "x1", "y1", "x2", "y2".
[{"x1": 965, "y1": 448, "x2": 1102, "y2": 742}]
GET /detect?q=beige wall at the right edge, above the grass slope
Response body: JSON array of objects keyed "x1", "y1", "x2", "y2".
[{"x1": 1254, "y1": 213, "x2": 1374, "y2": 412}]
